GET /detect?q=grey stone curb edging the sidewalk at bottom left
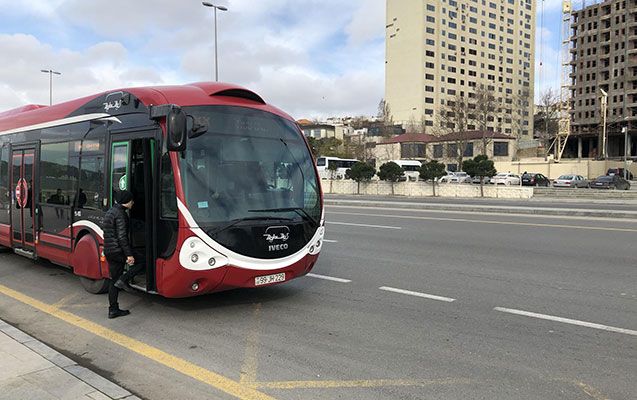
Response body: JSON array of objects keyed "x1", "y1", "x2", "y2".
[{"x1": 0, "y1": 319, "x2": 141, "y2": 400}]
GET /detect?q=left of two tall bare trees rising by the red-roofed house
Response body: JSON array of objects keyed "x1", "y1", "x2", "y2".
[{"x1": 436, "y1": 95, "x2": 472, "y2": 171}]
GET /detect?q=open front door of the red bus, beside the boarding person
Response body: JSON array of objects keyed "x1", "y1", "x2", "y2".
[{"x1": 108, "y1": 136, "x2": 157, "y2": 291}]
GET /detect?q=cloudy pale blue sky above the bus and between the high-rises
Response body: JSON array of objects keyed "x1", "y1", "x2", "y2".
[{"x1": 0, "y1": 0, "x2": 561, "y2": 118}]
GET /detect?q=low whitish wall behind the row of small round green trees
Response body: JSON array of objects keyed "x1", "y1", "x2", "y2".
[{"x1": 321, "y1": 179, "x2": 533, "y2": 199}]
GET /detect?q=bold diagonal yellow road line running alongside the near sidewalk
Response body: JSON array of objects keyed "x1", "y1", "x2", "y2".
[{"x1": 0, "y1": 285, "x2": 274, "y2": 400}]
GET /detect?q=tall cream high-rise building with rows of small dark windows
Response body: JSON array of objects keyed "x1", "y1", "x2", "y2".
[{"x1": 385, "y1": 0, "x2": 535, "y2": 140}]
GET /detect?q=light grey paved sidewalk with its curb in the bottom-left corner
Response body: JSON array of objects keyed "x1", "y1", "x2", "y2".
[{"x1": 0, "y1": 319, "x2": 139, "y2": 400}]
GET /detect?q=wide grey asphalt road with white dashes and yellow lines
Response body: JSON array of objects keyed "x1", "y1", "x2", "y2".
[{"x1": 0, "y1": 206, "x2": 637, "y2": 400}]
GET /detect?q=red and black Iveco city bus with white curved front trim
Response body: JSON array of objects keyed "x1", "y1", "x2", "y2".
[{"x1": 0, "y1": 83, "x2": 324, "y2": 297}]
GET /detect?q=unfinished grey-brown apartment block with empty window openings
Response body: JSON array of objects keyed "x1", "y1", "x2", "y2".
[{"x1": 565, "y1": 0, "x2": 637, "y2": 158}]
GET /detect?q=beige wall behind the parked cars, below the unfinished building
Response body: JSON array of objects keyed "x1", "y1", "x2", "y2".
[{"x1": 493, "y1": 159, "x2": 637, "y2": 179}]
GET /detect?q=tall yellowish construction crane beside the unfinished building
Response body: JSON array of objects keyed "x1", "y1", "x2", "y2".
[{"x1": 554, "y1": 0, "x2": 572, "y2": 161}]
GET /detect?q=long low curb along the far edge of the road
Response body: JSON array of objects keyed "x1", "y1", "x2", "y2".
[{"x1": 324, "y1": 199, "x2": 637, "y2": 220}]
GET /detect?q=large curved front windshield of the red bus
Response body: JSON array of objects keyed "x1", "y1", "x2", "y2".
[{"x1": 180, "y1": 106, "x2": 321, "y2": 231}]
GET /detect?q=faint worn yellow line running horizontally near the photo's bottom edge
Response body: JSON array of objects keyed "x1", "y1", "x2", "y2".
[{"x1": 252, "y1": 378, "x2": 471, "y2": 389}]
